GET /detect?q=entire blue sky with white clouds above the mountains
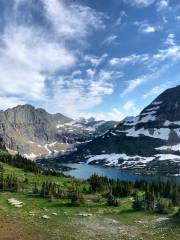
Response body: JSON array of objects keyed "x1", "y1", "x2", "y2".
[{"x1": 0, "y1": 0, "x2": 180, "y2": 121}]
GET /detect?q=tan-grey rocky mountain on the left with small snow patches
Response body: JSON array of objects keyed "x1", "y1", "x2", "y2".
[{"x1": 0, "y1": 104, "x2": 115, "y2": 159}]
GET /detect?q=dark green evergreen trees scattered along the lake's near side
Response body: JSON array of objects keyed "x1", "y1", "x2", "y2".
[{"x1": 0, "y1": 152, "x2": 180, "y2": 212}]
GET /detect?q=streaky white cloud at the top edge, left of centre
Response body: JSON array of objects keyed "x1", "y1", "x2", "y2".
[{"x1": 42, "y1": 0, "x2": 105, "y2": 40}]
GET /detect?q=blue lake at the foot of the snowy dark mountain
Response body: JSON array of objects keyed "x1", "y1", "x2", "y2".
[{"x1": 62, "y1": 163, "x2": 180, "y2": 184}]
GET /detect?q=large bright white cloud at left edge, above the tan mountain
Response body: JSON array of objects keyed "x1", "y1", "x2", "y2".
[{"x1": 0, "y1": 25, "x2": 76, "y2": 99}]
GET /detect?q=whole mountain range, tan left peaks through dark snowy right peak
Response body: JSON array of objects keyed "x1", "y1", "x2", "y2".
[{"x1": 0, "y1": 86, "x2": 180, "y2": 174}]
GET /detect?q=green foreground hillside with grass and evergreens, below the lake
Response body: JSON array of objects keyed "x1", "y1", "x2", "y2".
[{"x1": 0, "y1": 153, "x2": 180, "y2": 240}]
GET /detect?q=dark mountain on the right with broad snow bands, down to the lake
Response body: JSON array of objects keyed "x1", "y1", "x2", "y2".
[{"x1": 64, "y1": 86, "x2": 180, "y2": 174}]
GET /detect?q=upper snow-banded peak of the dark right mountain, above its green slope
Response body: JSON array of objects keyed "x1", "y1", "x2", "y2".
[{"x1": 116, "y1": 86, "x2": 180, "y2": 144}]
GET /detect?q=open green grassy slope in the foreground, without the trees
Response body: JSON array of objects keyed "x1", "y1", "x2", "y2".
[{"x1": 0, "y1": 164, "x2": 180, "y2": 240}]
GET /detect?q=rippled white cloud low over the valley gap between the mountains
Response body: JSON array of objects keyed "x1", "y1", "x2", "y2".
[{"x1": 49, "y1": 69, "x2": 121, "y2": 118}]
